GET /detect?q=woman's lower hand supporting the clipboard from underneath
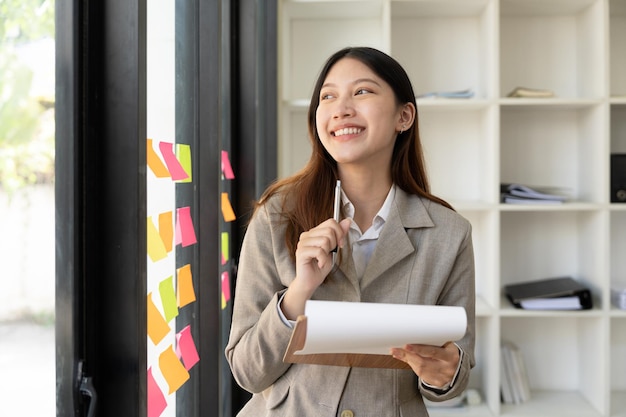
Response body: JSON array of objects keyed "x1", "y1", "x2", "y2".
[{"x1": 391, "y1": 342, "x2": 460, "y2": 387}]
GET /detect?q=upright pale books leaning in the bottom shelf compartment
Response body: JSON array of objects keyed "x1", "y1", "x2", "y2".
[{"x1": 500, "y1": 342, "x2": 530, "y2": 404}]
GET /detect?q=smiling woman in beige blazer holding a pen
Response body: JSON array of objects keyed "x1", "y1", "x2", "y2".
[{"x1": 226, "y1": 47, "x2": 475, "y2": 417}]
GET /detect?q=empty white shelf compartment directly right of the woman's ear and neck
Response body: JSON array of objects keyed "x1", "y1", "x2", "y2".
[{"x1": 418, "y1": 107, "x2": 497, "y2": 203}]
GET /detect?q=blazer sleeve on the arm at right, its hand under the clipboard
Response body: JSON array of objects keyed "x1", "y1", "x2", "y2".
[{"x1": 418, "y1": 219, "x2": 476, "y2": 401}]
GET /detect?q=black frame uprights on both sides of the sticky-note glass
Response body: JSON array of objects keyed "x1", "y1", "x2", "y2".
[{"x1": 55, "y1": 0, "x2": 277, "y2": 417}]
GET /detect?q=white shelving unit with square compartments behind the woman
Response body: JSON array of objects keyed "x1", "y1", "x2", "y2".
[{"x1": 278, "y1": 0, "x2": 626, "y2": 417}]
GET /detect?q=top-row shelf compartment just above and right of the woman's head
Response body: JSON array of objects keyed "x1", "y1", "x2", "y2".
[{"x1": 390, "y1": 0, "x2": 497, "y2": 99}]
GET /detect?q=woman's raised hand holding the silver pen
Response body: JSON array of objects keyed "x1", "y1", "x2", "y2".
[{"x1": 281, "y1": 219, "x2": 350, "y2": 320}]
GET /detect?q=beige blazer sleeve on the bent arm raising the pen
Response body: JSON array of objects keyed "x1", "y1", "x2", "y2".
[{"x1": 225, "y1": 202, "x2": 295, "y2": 393}]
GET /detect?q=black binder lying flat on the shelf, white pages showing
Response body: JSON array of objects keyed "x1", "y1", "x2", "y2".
[{"x1": 504, "y1": 277, "x2": 593, "y2": 310}]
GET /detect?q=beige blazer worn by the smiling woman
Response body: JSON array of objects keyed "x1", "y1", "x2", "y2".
[{"x1": 225, "y1": 188, "x2": 475, "y2": 417}]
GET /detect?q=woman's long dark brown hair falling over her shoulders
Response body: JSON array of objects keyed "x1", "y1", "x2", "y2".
[{"x1": 257, "y1": 47, "x2": 452, "y2": 257}]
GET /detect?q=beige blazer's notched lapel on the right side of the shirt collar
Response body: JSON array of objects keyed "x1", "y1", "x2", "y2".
[{"x1": 361, "y1": 188, "x2": 434, "y2": 288}]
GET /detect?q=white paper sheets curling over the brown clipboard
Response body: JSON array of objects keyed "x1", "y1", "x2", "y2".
[{"x1": 295, "y1": 300, "x2": 467, "y2": 355}]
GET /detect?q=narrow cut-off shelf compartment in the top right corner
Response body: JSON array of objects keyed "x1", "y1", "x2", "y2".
[{"x1": 609, "y1": 0, "x2": 626, "y2": 98}]
